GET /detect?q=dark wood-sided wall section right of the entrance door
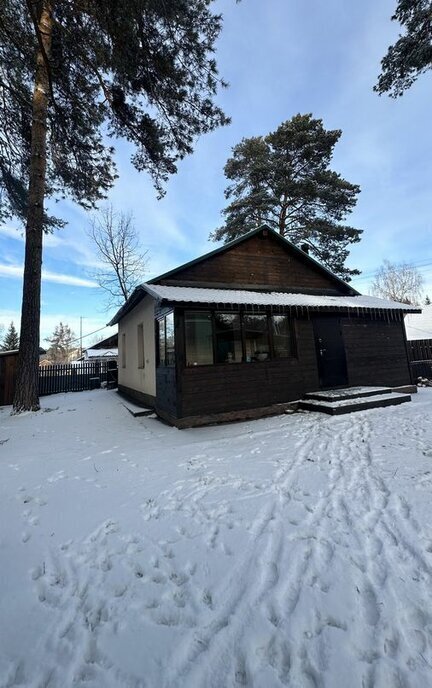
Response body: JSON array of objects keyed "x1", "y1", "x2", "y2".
[{"x1": 342, "y1": 317, "x2": 411, "y2": 387}]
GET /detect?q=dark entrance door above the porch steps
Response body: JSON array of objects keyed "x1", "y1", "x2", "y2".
[{"x1": 313, "y1": 317, "x2": 348, "y2": 389}]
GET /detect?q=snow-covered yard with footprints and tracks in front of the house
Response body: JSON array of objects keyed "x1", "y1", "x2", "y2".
[{"x1": 0, "y1": 389, "x2": 432, "y2": 688}]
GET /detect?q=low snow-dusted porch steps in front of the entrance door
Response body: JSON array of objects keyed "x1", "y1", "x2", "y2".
[{"x1": 299, "y1": 387, "x2": 411, "y2": 415}]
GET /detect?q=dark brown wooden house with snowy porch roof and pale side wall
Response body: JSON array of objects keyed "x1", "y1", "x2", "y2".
[{"x1": 110, "y1": 227, "x2": 418, "y2": 427}]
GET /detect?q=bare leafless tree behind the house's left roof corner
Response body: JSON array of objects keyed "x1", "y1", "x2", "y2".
[{"x1": 89, "y1": 205, "x2": 148, "y2": 310}]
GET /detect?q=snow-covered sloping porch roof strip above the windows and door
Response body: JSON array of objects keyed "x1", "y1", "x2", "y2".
[{"x1": 142, "y1": 284, "x2": 418, "y2": 312}]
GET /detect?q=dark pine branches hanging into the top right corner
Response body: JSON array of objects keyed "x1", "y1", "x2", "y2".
[{"x1": 374, "y1": 0, "x2": 432, "y2": 98}]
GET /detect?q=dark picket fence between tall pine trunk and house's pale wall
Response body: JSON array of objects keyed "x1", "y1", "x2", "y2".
[{"x1": 39, "y1": 361, "x2": 117, "y2": 396}]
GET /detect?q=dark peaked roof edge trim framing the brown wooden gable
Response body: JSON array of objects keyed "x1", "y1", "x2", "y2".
[{"x1": 146, "y1": 224, "x2": 359, "y2": 296}]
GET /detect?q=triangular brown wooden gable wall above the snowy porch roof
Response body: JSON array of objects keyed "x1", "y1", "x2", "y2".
[{"x1": 160, "y1": 234, "x2": 349, "y2": 294}]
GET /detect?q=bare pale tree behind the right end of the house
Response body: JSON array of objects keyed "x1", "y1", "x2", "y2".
[{"x1": 372, "y1": 260, "x2": 423, "y2": 305}]
